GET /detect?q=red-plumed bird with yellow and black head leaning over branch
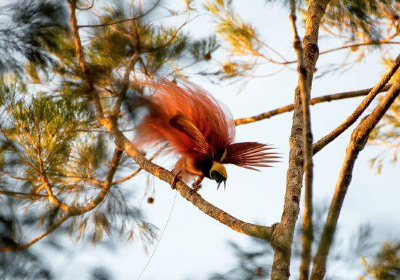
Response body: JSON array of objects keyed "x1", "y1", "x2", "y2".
[{"x1": 135, "y1": 79, "x2": 278, "y2": 191}]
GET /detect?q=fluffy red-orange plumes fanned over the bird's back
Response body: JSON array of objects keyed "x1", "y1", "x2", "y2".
[{"x1": 135, "y1": 79, "x2": 235, "y2": 158}]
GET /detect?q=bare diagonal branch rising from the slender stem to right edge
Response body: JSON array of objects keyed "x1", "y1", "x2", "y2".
[{"x1": 313, "y1": 55, "x2": 400, "y2": 155}]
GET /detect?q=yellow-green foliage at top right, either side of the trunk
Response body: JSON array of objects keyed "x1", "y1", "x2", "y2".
[{"x1": 202, "y1": 0, "x2": 400, "y2": 83}]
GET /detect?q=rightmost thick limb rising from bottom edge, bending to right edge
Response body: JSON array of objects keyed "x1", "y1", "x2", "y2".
[{"x1": 311, "y1": 80, "x2": 400, "y2": 280}]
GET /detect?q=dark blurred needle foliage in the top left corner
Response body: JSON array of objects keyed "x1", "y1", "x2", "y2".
[{"x1": 0, "y1": 0, "x2": 66, "y2": 73}]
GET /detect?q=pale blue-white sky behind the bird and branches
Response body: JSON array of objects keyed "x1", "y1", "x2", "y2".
[{"x1": 33, "y1": 0, "x2": 400, "y2": 280}]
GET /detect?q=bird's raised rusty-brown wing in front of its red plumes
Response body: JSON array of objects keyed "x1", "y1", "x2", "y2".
[{"x1": 169, "y1": 113, "x2": 212, "y2": 155}]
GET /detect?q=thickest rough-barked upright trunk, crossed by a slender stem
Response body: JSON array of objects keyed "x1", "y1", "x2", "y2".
[{"x1": 271, "y1": 0, "x2": 329, "y2": 280}]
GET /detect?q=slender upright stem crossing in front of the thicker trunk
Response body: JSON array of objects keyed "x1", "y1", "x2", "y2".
[{"x1": 289, "y1": 0, "x2": 313, "y2": 280}]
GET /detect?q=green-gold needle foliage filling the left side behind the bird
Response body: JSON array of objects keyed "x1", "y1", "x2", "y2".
[{"x1": 0, "y1": 0, "x2": 223, "y2": 254}]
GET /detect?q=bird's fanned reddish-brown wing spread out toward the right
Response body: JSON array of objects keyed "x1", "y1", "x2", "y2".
[{"x1": 222, "y1": 142, "x2": 280, "y2": 171}]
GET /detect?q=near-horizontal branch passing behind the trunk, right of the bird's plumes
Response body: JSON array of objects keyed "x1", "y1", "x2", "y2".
[{"x1": 235, "y1": 84, "x2": 391, "y2": 126}]
